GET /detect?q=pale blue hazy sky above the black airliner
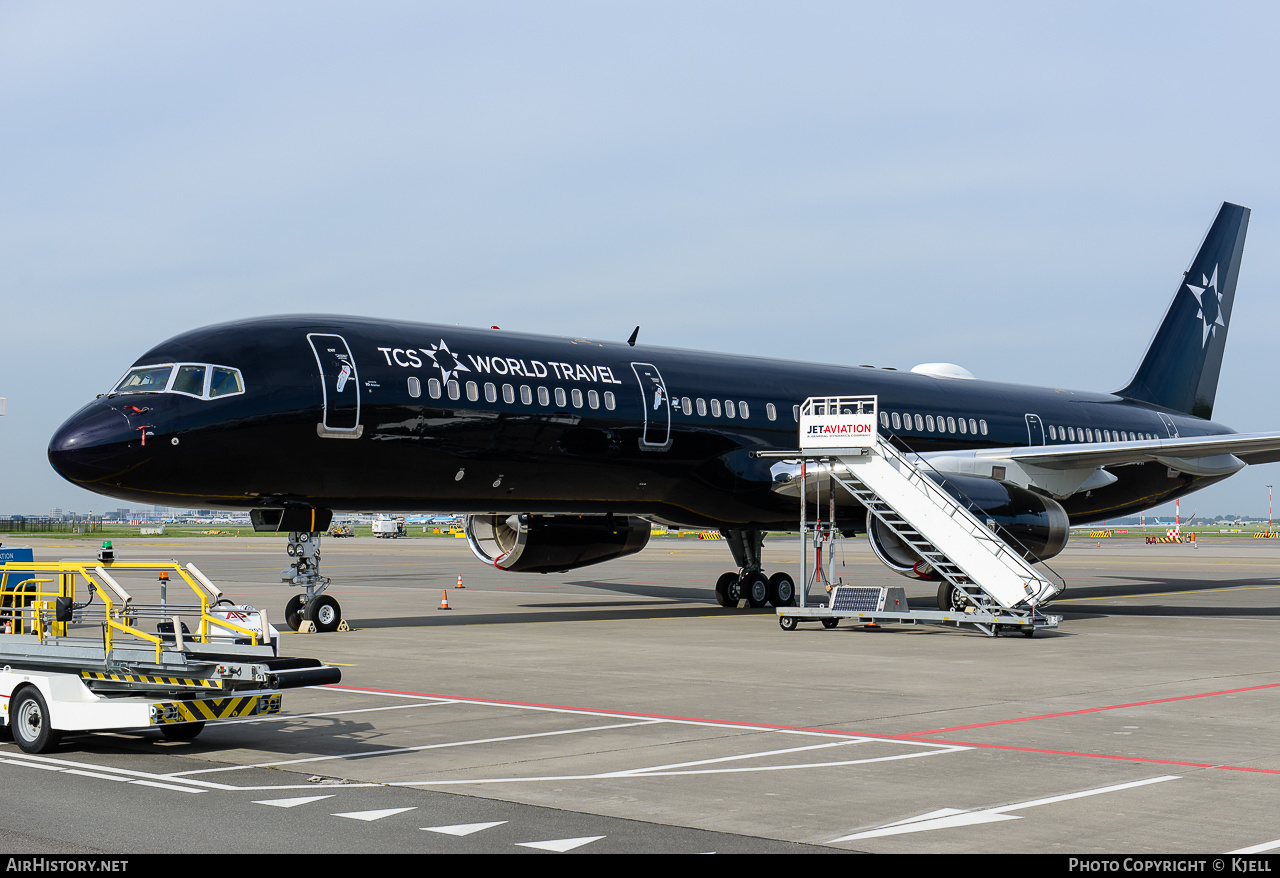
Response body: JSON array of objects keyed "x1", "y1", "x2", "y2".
[{"x1": 0, "y1": 0, "x2": 1280, "y2": 513}]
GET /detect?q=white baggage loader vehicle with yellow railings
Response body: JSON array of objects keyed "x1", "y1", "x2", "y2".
[{"x1": 0, "y1": 544, "x2": 342, "y2": 753}]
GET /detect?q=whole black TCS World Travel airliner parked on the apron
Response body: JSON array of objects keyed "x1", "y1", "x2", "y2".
[{"x1": 49, "y1": 204, "x2": 1280, "y2": 628}]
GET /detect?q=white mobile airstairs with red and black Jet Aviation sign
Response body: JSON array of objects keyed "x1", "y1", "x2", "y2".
[{"x1": 762, "y1": 395, "x2": 1065, "y2": 636}]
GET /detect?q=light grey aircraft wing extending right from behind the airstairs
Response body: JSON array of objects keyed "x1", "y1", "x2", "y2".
[{"x1": 962, "y1": 433, "x2": 1280, "y2": 470}]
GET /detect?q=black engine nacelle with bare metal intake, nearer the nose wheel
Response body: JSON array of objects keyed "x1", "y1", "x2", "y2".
[{"x1": 466, "y1": 515, "x2": 649, "y2": 573}]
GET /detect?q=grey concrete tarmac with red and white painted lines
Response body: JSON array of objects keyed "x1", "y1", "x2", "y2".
[{"x1": 0, "y1": 535, "x2": 1280, "y2": 854}]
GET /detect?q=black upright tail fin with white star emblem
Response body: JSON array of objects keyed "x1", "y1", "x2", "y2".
[{"x1": 1116, "y1": 201, "x2": 1249, "y2": 419}]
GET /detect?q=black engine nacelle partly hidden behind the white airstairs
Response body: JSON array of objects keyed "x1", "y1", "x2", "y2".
[{"x1": 867, "y1": 474, "x2": 1071, "y2": 580}]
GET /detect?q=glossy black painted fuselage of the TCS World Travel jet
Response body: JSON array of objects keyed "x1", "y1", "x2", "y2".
[{"x1": 49, "y1": 316, "x2": 1230, "y2": 529}]
